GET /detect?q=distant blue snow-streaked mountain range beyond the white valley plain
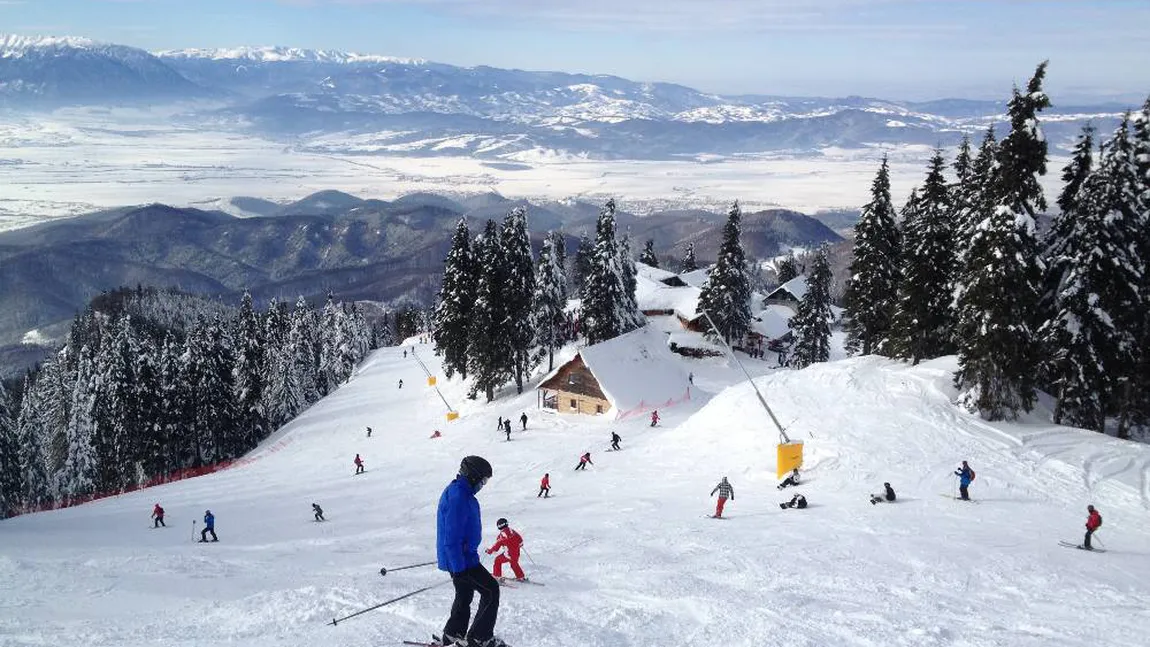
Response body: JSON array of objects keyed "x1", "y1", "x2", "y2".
[{"x1": 0, "y1": 36, "x2": 1124, "y2": 160}]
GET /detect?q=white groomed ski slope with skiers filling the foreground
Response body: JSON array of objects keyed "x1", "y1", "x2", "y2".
[{"x1": 0, "y1": 346, "x2": 1150, "y2": 647}]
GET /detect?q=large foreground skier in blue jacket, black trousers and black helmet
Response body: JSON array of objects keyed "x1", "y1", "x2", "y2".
[{"x1": 436, "y1": 456, "x2": 506, "y2": 647}]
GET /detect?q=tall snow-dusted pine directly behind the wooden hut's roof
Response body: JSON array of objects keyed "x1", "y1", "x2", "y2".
[{"x1": 580, "y1": 200, "x2": 638, "y2": 344}]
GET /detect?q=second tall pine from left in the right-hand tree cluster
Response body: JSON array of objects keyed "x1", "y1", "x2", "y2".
[{"x1": 890, "y1": 149, "x2": 956, "y2": 364}]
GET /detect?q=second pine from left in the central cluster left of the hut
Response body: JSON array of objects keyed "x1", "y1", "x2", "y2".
[{"x1": 467, "y1": 221, "x2": 513, "y2": 402}]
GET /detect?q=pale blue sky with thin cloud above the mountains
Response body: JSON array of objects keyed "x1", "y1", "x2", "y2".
[{"x1": 0, "y1": 0, "x2": 1150, "y2": 105}]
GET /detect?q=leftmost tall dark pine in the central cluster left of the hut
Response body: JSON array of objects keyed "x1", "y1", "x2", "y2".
[{"x1": 431, "y1": 218, "x2": 478, "y2": 379}]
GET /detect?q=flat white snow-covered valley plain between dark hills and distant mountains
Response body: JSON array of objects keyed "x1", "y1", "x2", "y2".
[{"x1": 0, "y1": 107, "x2": 1061, "y2": 230}]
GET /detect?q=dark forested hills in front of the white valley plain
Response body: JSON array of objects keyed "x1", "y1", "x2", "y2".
[{"x1": 0, "y1": 191, "x2": 841, "y2": 368}]
